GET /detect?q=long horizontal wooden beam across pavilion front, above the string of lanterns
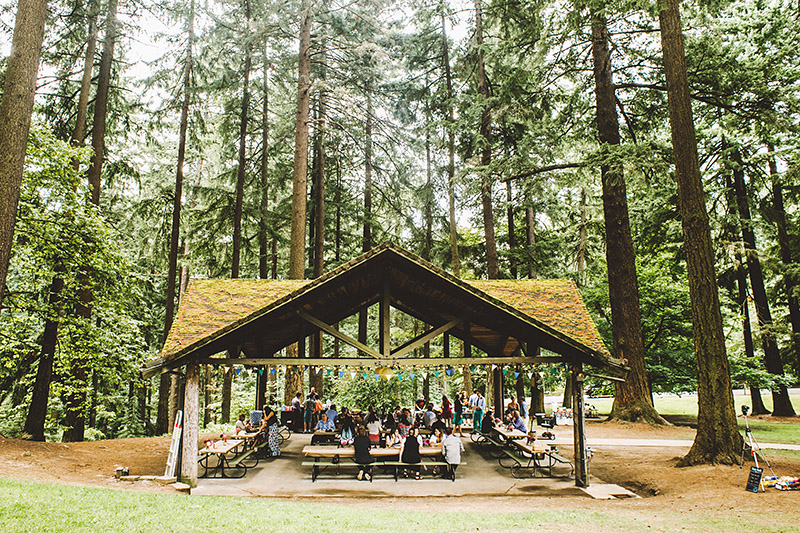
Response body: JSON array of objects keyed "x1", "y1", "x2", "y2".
[{"x1": 198, "y1": 356, "x2": 562, "y2": 367}]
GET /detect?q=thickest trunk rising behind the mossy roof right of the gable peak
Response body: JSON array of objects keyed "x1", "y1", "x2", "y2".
[{"x1": 475, "y1": 0, "x2": 500, "y2": 279}]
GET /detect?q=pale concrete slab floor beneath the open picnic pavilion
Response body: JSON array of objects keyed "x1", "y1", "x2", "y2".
[{"x1": 192, "y1": 434, "x2": 608, "y2": 501}]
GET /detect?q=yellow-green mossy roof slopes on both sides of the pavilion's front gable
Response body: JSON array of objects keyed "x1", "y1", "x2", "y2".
[{"x1": 161, "y1": 279, "x2": 610, "y2": 357}]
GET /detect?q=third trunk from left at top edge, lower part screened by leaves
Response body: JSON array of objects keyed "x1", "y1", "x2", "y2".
[{"x1": 63, "y1": 0, "x2": 117, "y2": 442}]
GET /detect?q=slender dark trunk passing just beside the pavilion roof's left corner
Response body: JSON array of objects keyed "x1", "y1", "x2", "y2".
[{"x1": 156, "y1": 0, "x2": 194, "y2": 435}]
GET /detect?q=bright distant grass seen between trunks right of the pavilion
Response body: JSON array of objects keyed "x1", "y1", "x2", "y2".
[{"x1": 586, "y1": 394, "x2": 800, "y2": 444}]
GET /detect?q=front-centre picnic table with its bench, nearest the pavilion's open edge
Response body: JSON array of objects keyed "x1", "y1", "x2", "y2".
[{"x1": 303, "y1": 446, "x2": 455, "y2": 482}]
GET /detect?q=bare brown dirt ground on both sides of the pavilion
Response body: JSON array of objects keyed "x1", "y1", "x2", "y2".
[{"x1": 0, "y1": 417, "x2": 800, "y2": 513}]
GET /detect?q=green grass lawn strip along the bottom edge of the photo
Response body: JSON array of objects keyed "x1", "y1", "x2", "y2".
[{"x1": 0, "y1": 479, "x2": 798, "y2": 533}]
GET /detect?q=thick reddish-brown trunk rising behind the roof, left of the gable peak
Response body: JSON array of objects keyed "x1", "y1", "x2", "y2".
[{"x1": 286, "y1": 0, "x2": 311, "y2": 280}]
